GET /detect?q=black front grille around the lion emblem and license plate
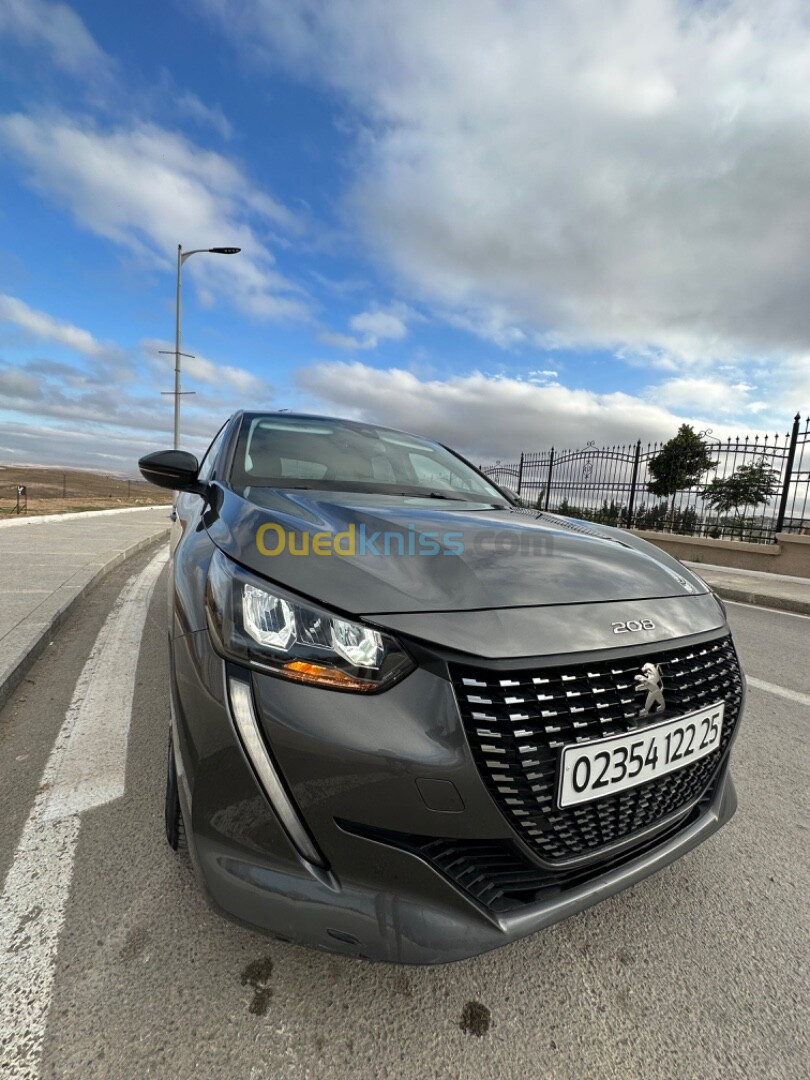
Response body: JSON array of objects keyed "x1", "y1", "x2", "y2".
[{"x1": 450, "y1": 637, "x2": 742, "y2": 863}]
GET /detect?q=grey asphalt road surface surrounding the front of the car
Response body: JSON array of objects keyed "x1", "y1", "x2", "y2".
[{"x1": 0, "y1": 552, "x2": 810, "y2": 1080}]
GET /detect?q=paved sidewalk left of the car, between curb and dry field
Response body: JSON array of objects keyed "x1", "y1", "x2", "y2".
[{"x1": 0, "y1": 505, "x2": 172, "y2": 706}]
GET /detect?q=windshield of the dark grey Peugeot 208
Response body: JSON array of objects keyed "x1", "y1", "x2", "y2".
[{"x1": 230, "y1": 414, "x2": 504, "y2": 507}]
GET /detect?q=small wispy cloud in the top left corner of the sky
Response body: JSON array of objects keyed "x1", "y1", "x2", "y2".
[{"x1": 0, "y1": 0, "x2": 112, "y2": 78}]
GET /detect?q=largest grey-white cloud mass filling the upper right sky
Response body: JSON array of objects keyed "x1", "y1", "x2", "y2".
[{"x1": 205, "y1": 0, "x2": 810, "y2": 357}]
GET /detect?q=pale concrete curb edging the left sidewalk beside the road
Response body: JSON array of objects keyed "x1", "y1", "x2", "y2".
[{"x1": 0, "y1": 527, "x2": 171, "y2": 708}]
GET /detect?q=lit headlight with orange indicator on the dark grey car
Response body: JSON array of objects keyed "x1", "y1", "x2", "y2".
[{"x1": 205, "y1": 551, "x2": 414, "y2": 693}]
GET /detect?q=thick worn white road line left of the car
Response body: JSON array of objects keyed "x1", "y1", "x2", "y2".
[{"x1": 0, "y1": 550, "x2": 168, "y2": 1080}]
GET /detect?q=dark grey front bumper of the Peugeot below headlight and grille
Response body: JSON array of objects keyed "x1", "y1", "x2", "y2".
[{"x1": 173, "y1": 631, "x2": 737, "y2": 963}]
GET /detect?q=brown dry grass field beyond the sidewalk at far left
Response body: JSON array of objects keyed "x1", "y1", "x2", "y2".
[{"x1": 0, "y1": 465, "x2": 172, "y2": 518}]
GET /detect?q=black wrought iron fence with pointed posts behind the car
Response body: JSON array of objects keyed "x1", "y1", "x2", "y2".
[{"x1": 482, "y1": 413, "x2": 810, "y2": 543}]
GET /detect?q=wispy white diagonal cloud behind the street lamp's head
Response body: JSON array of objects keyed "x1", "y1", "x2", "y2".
[{"x1": 0, "y1": 113, "x2": 309, "y2": 319}]
